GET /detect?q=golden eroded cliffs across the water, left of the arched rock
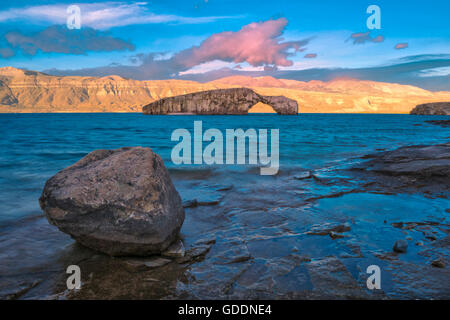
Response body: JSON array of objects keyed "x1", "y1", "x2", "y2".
[{"x1": 0, "y1": 67, "x2": 229, "y2": 113}]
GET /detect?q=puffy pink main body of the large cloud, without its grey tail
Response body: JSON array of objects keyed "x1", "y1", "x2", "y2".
[{"x1": 174, "y1": 18, "x2": 308, "y2": 68}]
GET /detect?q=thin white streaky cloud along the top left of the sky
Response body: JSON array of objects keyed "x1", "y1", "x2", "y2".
[{"x1": 0, "y1": 2, "x2": 236, "y2": 30}]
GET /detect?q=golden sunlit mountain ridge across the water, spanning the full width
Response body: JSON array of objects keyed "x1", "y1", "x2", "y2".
[{"x1": 0, "y1": 67, "x2": 450, "y2": 113}]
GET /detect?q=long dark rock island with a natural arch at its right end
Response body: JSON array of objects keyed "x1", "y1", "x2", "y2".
[{"x1": 142, "y1": 88, "x2": 298, "y2": 115}]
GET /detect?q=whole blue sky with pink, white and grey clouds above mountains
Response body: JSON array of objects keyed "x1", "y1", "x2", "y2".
[{"x1": 0, "y1": 0, "x2": 450, "y2": 91}]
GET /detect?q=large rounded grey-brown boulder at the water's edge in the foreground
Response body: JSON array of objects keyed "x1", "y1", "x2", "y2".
[{"x1": 39, "y1": 147, "x2": 184, "y2": 256}]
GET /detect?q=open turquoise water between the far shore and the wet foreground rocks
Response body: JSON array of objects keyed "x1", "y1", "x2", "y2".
[{"x1": 0, "y1": 114, "x2": 450, "y2": 222}]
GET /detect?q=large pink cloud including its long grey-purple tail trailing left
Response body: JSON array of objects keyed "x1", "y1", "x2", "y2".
[{"x1": 45, "y1": 18, "x2": 309, "y2": 79}]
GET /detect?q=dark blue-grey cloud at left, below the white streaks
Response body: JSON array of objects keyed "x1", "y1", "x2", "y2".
[{"x1": 0, "y1": 26, "x2": 135, "y2": 58}]
